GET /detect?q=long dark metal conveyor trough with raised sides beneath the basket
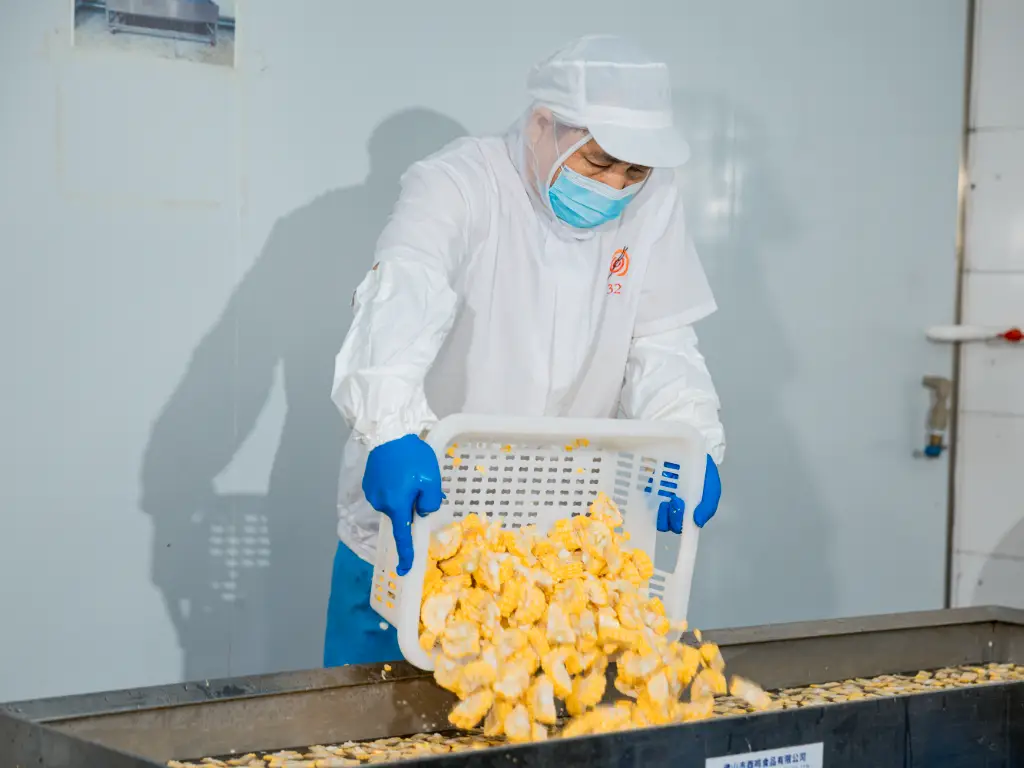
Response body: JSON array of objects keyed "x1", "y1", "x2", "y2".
[{"x1": 6, "y1": 608, "x2": 1024, "y2": 768}]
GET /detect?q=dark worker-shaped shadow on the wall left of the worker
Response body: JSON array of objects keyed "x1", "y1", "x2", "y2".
[{"x1": 141, "y1": 110, "x2": 466, "y2": 680}]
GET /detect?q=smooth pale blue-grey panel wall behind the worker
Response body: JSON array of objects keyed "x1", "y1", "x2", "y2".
[{"x1": 0, "y1": 0, "x2": 964, "y2": 699}]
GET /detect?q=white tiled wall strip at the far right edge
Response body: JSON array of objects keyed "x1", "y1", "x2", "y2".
[{"x1": 952, "y1": 0, "x2": 1024, "y2": 607}]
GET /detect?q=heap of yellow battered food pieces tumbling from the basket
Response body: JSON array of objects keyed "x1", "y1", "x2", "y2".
[{"x1": 420, "y1": 494, "x2": 770, "y2": 742}]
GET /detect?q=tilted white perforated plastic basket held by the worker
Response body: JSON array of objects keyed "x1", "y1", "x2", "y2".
[{"x1": 370, "y1": 414, "x2": 707, "y2": 670}]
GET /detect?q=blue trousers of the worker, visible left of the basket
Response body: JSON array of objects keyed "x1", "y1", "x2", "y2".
[{"x1": 324, "y1": 542, "x2": 402, "y2": 667}]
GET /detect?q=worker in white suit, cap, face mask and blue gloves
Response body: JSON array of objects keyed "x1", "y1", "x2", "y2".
[{"x1": 325, "y1": 36, "x2": 725, "y2": 667}]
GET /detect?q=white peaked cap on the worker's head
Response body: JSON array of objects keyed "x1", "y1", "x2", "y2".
[{"x1": 526, "y1": 35, "x2": 690, "y2": 168}]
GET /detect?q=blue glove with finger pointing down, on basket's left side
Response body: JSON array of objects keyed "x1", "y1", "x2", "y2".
[{"x1": 362, "y1": 434, "x2": 444, "y2": 575}]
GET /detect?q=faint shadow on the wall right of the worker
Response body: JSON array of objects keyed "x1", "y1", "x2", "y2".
[{"x1": 675, "y1": 91, "x2": 837, "y2": 629}]
